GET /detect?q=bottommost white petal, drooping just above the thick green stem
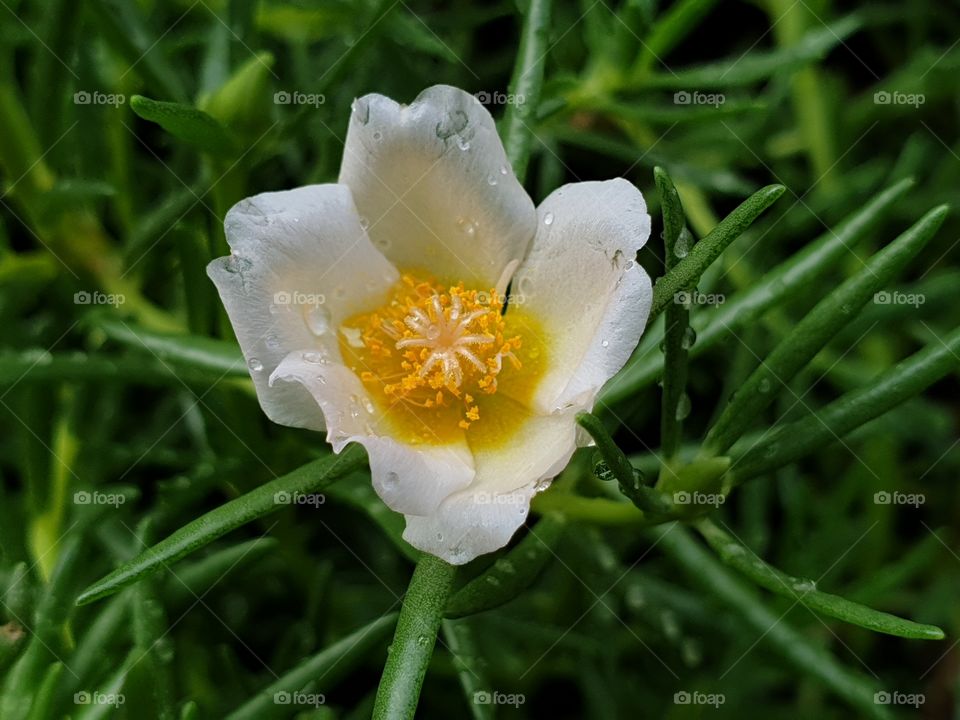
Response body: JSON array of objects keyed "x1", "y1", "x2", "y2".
[{"x1": 403, "y1": 413, "x2": 577, "y2": 565}]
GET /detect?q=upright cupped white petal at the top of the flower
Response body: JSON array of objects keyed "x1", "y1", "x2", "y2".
[{"x1": 339, "y1": 85, "x2": 536, "y2": 289}]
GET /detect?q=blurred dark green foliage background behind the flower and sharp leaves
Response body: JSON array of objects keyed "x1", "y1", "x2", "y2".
[{"x1": 0, "y1": 0, "x2": 960, "y2": 720}]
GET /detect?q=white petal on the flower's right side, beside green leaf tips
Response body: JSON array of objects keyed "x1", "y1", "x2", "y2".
[{"x1": 507, "y1": 179, "x2": 653, "y2": 412}]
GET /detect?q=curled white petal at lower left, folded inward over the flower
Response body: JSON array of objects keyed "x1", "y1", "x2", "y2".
[{"x1": 270, "y1": 352, "x2": 474, "y2": 514}]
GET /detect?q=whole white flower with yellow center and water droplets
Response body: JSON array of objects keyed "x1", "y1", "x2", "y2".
[{"x1": 208, "y1": 86, "x2": 652, "y2": 564}]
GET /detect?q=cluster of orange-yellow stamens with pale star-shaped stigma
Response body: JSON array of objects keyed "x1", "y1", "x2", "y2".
[{"x1": 343, "y1": 275, "x2": 520, "y2": 429}]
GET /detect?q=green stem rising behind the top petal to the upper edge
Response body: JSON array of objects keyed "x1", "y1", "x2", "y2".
[{"x1": 503, "y1": 0, "x2": 551, "y2": 183}]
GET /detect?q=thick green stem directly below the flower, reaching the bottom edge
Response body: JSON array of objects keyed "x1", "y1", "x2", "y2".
[{"x1": 373, "y1": 553, "x2": 457, "y2": 720}]
